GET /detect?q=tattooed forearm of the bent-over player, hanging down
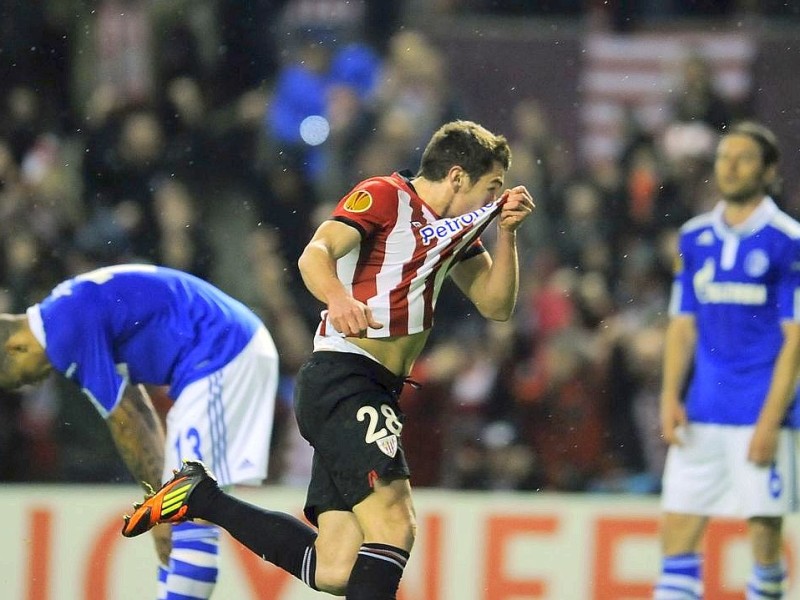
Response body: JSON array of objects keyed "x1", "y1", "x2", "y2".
[{"x1": 108, "y1": 385, "x2": 165, "y2": 489}]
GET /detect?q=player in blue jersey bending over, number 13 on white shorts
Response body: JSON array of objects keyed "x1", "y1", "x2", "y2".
[{"x1": 0, "y1": 265, "x2": 278, "y2": 600}]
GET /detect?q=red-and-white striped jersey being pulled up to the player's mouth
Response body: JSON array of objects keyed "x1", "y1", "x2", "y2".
[{"x1": 317, "y1": 173, "x2": 501, "y2": 338}]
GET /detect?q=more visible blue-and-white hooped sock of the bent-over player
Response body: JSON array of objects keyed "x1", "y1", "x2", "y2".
[{"x1": 159, "y1": 522, "x2": 219, "y2": 600}]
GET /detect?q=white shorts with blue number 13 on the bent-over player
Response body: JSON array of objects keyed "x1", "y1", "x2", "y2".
[{"x1": 163, "y1": 327, "x2": 279, "y2": 486}]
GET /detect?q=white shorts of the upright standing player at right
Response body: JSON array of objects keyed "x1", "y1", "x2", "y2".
[{"x1": 661, "y1": 423, "x2": 800, "y2": 518}]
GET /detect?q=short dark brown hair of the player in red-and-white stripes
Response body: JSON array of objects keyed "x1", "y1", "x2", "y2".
[{"x1": 418, "y1": 121, "x2": 511, "y2": 181}]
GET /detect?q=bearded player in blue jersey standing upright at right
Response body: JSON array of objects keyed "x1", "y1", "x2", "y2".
[{"x1": 655, "y1": 122, "x2": 800, "y2": 600}]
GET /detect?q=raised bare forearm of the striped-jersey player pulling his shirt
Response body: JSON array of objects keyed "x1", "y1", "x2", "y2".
[{"x1": 476, "y1": 229, "x2": 519, "y2": 321}]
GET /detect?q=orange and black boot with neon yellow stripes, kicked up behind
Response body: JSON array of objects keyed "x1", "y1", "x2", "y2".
[{"x1": 122, "y1": 460, "x2": 216, "y2": 537}]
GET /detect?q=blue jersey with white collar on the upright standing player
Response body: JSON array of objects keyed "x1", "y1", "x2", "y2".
[{"x1": 670, "y1": 197, "x2": 800, "y2": 427}]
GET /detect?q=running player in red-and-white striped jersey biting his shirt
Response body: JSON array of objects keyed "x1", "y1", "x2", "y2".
[{"x1": 123, "y1": 121, "x2": 533, "y2": 600}]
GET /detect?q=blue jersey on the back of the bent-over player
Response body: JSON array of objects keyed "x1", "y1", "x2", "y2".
[{"x1": 28, "y1": 265, "x2": 261, "y2": 416}]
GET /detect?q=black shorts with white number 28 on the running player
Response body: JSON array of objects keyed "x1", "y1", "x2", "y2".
[{"x1": 295, "y1": 352, "x2": 410, "y2": 525}]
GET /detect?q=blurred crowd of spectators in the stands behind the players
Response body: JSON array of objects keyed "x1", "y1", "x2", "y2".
[{"x1": 0, "y1": 0, "x2": 792, "y2": 493}]
